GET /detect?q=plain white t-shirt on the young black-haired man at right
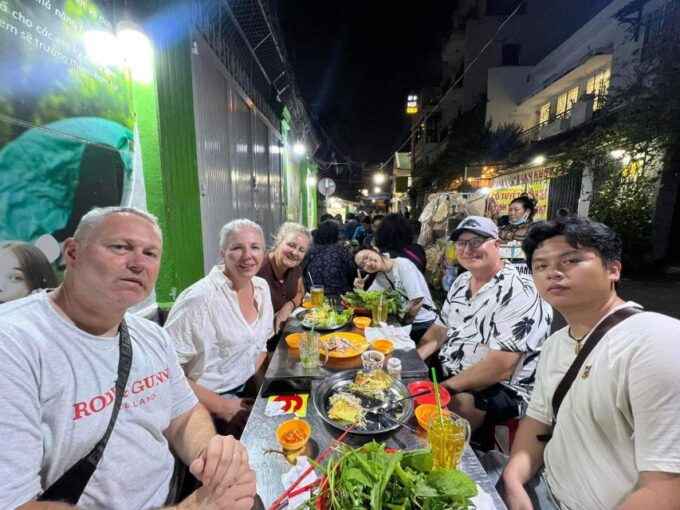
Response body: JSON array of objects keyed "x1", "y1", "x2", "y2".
[{"x1": 527, "y1": 302, "x2": 680, "y2": 510}]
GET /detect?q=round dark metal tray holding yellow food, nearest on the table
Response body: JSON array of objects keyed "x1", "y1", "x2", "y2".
[{"x1": 312, "y1": 370, "x2": 413, "y2": 436}]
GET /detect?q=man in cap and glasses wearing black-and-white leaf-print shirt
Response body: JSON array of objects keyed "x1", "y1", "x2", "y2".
[{"x1": 418, "y1": 216, "x2": 552, "y2": 430}]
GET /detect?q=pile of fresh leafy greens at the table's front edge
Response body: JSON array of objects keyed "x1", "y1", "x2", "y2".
[{"x1": 305, "y1": 441, "x2": 477, "y2": 510}]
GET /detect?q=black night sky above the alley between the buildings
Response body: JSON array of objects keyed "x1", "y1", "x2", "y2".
[{"x1": 279, "y1": 0, "x2": 457, "y2": 171}]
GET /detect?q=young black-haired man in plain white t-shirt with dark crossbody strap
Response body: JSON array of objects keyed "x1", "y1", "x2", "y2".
[{"x1": 502, "y1": 217, "x2": 680, "y2": 510}]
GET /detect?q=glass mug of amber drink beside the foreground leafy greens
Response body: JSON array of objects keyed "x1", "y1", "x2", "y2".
[{"x1": 427, "y1": 411, "x2": 470, "y2": 469}]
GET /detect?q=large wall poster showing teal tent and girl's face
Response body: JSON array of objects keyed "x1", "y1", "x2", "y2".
[{"x1": 0, "y1": 0, "x2": 145, "y2": 302}]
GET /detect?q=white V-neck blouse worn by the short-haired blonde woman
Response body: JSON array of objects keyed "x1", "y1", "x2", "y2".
[{"x1": 165, "y1": 266, "x2": 274, "y2": 393}]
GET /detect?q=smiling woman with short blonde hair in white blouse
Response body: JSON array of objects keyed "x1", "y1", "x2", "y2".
[{"x1": 165, "y1": 219, "x2": 274, "y2": 429}]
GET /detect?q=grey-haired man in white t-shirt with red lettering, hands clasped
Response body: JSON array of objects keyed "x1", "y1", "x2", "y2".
[{"x1": 0, "y1": 207, "x2": 255, "y2": 510}]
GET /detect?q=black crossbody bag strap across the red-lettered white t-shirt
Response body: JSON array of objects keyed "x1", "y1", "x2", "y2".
[{"x1": 37, "y1": 320, "x2": 132, "y2": 505}]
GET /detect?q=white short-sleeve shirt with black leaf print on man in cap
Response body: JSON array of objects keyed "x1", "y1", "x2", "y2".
[{"x1": 437, "y1": 262, "x2": 552, "y2": 399}]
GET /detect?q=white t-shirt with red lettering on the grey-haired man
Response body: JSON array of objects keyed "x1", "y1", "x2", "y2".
[{"x1": 0, "y1": 292, "x2": 198, "y2": 510}]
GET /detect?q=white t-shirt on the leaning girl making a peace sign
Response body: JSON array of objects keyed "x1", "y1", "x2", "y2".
[{"x1": 368, "y1": 257, "x2": 437, "y2": 323}]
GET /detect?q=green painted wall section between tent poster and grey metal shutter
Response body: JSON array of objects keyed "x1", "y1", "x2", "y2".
[{"x1": 146, "y1": 10, "x2": 204, "y2": 307}]
